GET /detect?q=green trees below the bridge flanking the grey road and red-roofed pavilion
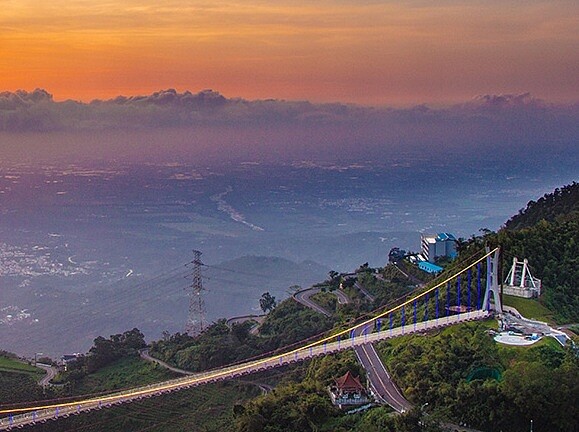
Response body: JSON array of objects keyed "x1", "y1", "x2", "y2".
[{"x1": 234, "y1": 321, "x2": 579, "y2": 432}]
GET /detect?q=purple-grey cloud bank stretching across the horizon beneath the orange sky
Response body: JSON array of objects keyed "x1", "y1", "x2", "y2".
[{"x1": 0, "y1": 89, "x2": 579, "y2": 165}]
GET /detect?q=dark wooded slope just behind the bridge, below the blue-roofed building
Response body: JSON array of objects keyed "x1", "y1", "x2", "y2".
[{"x1": 151, "y1": 264, "x2": 422, "y2": 372}]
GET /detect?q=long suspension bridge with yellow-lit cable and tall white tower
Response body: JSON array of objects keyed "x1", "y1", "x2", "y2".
[{"x1": 0, "y1": 248, "x2": 502, "y2": 430}]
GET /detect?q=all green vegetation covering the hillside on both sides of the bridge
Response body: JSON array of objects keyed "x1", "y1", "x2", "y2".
[{"x1": 0, "y1": 183, "x2": 579, "y2": 432}]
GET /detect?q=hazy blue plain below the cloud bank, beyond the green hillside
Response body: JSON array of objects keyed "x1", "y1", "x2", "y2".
[{"x1": 0, "y1": 158, "x2": 576, "y2": 356}]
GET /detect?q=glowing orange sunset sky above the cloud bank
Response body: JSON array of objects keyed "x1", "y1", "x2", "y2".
[{"x1": 0, "y1": 0, "x2": 579, "y2": 105}]
